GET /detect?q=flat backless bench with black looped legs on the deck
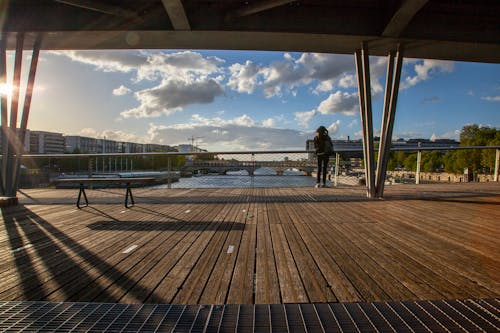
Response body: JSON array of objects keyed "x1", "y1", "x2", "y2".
[{"x1": 55, "y1": 177, "x2": 156, "y2": 209}]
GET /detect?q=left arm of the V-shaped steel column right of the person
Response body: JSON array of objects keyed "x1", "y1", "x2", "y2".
[{"x1": 355, "y1": 46, "x2": 375, "y2": 198}]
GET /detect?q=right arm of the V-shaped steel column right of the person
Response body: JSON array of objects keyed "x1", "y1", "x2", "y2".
[{"x1": 375, "y1": 50, "x2": 403, "y2": 198}]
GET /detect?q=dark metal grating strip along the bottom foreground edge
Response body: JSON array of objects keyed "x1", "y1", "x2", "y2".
[{"x1": 0, "y1": 299, "x2": 500, "y2": 333}]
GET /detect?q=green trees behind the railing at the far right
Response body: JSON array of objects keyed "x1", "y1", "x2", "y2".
[{"x1": 387, "y1": 124, "x2": 500, "y2": 174}]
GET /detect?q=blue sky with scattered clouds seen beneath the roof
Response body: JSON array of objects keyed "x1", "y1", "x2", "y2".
[{"x1": 0, "y1": 50, "x2": 500, "y2": 151}]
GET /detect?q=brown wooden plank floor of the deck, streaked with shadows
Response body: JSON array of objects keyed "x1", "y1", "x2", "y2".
[{"x1": 0, "y1": 183, "x2": 500, "y2": 304}]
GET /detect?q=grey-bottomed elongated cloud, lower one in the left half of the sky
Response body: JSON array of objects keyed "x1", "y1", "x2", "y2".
[{"x1": 121, "y1": 79, "x2": 223, "y2": 118}]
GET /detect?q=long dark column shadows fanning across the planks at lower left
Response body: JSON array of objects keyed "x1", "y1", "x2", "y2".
[{"x1": 1, "y1": 206, "x2": 161, "y2": 302}]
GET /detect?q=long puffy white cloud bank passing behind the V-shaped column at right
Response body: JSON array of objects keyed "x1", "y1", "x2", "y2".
[{"x1": 228, "y1": 53, "x2": 454, "y2": 98}]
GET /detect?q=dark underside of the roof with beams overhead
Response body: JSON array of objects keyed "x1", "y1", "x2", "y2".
[{"x1": 0, "y1": 0, "x2": 500, "y2": 63}]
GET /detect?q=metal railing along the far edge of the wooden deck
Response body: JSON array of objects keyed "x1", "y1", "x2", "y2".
[{"x1": 3, "y1": 146, "x2": 500, "y2": 188}]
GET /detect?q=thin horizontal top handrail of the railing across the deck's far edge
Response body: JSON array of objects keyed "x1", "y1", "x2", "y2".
[{"x1": 0, "y1": 145, "x2": 500, "y2": 158}]
